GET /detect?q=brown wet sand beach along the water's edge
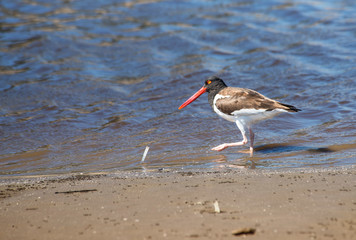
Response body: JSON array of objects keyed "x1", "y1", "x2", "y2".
[{"x1": 0, "y1": 167, "x2": 356, "y2": 239}]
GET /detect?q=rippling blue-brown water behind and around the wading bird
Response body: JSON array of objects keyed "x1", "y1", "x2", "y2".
[{"x1": 0, "y1": 0, "x2": 356, "y2": 176}]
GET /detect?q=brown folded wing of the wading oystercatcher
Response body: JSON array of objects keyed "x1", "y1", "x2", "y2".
[{"x1": 216, "y1": 87, "x2": 299, "y2": 115}]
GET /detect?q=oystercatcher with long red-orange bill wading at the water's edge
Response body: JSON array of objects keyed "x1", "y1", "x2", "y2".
[{"x1": 178, "y1": 76, "x2": 300, "y2": 156}]
